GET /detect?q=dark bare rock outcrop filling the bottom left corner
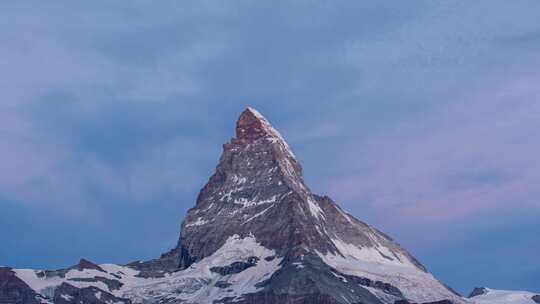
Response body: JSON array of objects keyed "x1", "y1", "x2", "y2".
[{"x1": 0, "y1": 267, "x2": 41, "y2": 304}]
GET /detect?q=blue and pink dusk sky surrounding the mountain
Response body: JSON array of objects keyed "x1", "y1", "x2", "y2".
[{"x1": 0, "y1": 0, "x2": 540, "y2": 294}]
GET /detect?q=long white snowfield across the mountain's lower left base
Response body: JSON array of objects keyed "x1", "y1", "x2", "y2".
[{"x1": 14, "y1": 235, "x2": 281, "y2": 303}]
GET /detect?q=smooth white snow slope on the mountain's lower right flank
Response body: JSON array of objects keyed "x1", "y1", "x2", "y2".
[{"x1": 319, "y1": 240, "x2": 467, "y2": 303}]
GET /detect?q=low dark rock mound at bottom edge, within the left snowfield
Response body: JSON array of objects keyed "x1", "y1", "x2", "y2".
[{"x1": 53, "y1": 283, "x2": 131, "y2": 304}]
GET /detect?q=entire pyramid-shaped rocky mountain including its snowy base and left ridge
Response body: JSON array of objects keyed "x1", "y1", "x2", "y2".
[{"x1": 0, "y1": 108, "x2": 468, "y2": 304}]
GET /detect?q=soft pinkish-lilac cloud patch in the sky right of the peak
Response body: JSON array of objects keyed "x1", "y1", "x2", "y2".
[{"x1": 328, "y1": 77, "x2": 540, "y2": 226}]
